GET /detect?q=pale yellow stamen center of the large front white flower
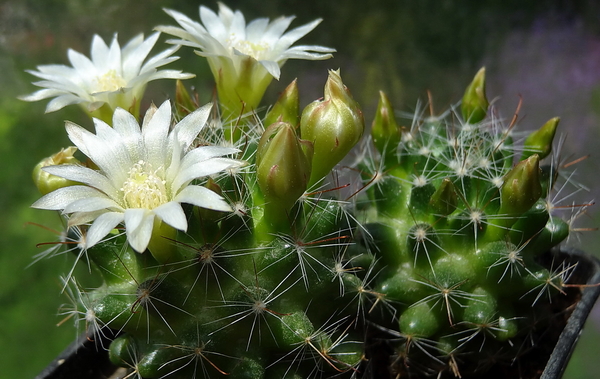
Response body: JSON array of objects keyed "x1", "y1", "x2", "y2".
[{"x1": 121, "y1": 161, "x2": 169, "y2": 209}]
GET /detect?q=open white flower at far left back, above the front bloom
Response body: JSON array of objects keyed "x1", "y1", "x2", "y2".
[{"x1": 21, "y1": 33, "x2": 194, "y2": 122}]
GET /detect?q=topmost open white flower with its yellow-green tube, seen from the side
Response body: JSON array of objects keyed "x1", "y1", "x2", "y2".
[{"x1": 156, "y1": 3, "x2": 335, "y2": 117}]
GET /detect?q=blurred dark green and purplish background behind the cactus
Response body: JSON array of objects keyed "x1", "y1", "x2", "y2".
[{"x1": 0, "y1": 0, "x2": 600, "y2": 379}]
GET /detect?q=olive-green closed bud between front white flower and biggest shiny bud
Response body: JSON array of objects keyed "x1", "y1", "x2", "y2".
[{"x1": 256, "y1": 122, "x2": 313, "y2": 215}]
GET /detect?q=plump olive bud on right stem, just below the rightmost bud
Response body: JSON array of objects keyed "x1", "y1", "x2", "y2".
[{"x1": 499, "y1": 154, "x2": 542, "y2": 220}]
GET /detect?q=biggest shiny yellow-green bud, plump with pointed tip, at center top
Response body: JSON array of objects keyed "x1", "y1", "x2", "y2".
[{"x1": 300, "y1": 70, "x2": 365, "y2": 185}]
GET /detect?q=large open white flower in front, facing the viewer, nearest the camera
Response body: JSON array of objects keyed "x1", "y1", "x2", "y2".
[{"x1": 32, "y1": 101, "x2": 241, "y2": 254}]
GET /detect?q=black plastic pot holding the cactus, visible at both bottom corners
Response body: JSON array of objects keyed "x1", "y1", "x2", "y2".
[{"x1": 36, "y1": 249, "x2": 600, "y2": 379}]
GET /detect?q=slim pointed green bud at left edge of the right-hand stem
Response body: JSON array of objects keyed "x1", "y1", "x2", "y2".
[{"x1": 371, "y1": 91, "x2": 402, "y2": 160}]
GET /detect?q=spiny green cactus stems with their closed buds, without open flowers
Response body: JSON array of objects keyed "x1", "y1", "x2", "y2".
[{"x1": 25, "y1": 3, "x2": 585, "y2": 379}]
